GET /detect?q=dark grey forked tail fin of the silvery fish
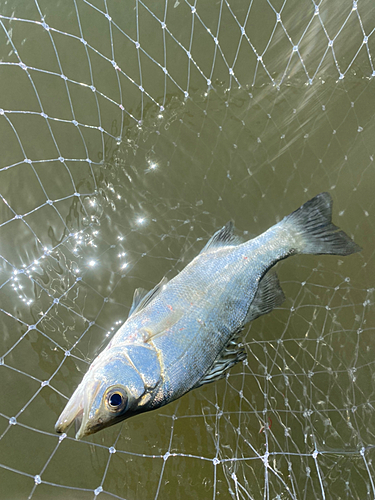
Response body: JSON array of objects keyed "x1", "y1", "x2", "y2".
[{"x1": 282, "y1": 193, "x2": 361, "y2": 255}]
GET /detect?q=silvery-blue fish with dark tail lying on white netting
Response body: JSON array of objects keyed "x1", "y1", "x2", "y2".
[{"x1": 55, "y1": 193, "x2": 361, "y2": 439}]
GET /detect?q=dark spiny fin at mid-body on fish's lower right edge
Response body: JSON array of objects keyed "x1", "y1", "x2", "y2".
[{"x1": 193, "y1": 328, "x2": 247, "y2": 389}]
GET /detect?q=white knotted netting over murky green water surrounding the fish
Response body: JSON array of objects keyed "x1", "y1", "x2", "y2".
[{"x1": 0, "y1": 0, "x2": 375, "y2": 500}]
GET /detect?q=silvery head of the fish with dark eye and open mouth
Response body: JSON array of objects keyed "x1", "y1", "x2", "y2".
[{"x1": 55, "y1": 352, "x2": 146, "y2": 439}]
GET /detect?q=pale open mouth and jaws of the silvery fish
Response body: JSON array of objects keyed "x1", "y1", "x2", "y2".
[{"x1": 55, "y1": 380, "x2": 100, "y2": 439}]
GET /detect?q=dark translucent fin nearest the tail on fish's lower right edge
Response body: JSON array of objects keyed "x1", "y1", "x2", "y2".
[{"x1": 245, "y1": 271, "x2": 285, "y2": 323}]
